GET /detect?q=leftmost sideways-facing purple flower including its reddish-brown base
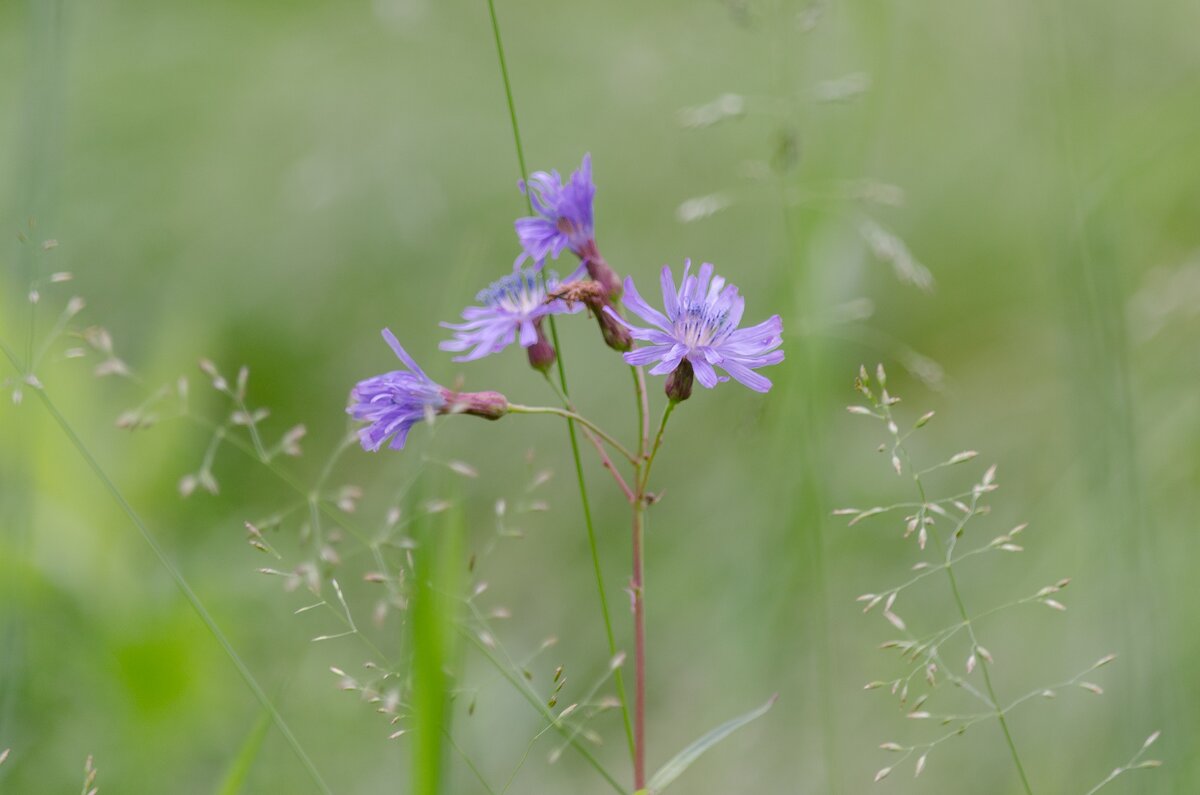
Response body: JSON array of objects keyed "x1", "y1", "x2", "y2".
[{"x1": 346, "y1": 329, "x2": 509, "y2": 452}]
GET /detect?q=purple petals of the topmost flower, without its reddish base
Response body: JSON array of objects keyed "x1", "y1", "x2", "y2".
[{"x1": 516, "y1": 154, "x2": 596, "y2": 267}]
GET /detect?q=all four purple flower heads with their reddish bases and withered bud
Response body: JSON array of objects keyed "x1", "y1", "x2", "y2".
[{"x1": 347, "y1": 155, "x2": 784, "y2": 450}]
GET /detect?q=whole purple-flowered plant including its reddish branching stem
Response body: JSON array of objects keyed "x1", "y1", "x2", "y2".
[{"x1": 347, "y1": 155, "x2": 784, "y2": 793}]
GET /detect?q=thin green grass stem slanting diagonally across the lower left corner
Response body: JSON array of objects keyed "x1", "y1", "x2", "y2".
[{"x1": 0, "y1": 342, "x2": 332, "y2": 795}]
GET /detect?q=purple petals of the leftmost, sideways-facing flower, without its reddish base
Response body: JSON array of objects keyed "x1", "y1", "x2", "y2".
[{"x1": 346, "y1": 329, "x2": 448, "y2": 452}]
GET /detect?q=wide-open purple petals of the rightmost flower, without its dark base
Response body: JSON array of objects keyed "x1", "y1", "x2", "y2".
[{"x1": 606, "y1": 261, "x2": 784, "y2": 391}]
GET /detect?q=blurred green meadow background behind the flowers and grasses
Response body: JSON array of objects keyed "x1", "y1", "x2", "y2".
[{"x1": 0, "y1": 0, "x2": 1200, "y2": 794}]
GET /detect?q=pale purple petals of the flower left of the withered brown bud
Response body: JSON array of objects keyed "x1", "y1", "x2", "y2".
[{"x1": 439, "y1": 268, "x2": 583, "y2": 361}]
